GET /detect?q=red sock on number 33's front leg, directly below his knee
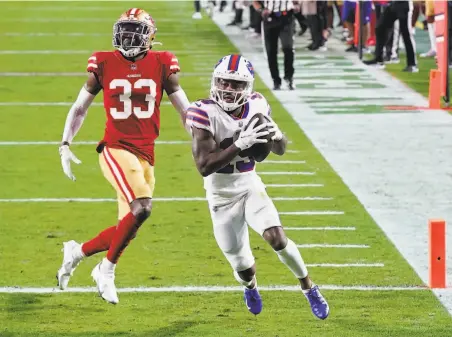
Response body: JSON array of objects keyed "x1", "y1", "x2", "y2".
[{"x1": 107, "y1": 212, "x2": 141, "y2": 263}]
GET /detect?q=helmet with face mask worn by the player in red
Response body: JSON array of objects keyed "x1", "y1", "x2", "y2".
[{"x1": 113, "y1": 8, "x2": 157, "y2": 57}]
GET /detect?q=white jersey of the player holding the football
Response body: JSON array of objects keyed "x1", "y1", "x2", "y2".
[{"x1": 186, "y1": 92, "x2": 271, "y2": 197}]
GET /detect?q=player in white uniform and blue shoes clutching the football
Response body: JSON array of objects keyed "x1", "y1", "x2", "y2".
[{"x1": 187, "y1": 55, "x2": 329, "y2": 319}]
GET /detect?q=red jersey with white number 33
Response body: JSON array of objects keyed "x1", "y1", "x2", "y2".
[{"x1": 87, "y1": 51, "x2": 180, "y2": 165}]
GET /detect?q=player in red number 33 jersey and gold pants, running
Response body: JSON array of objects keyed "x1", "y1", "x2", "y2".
[{"x1": 57, "y1": 8, "x2": 190, "y2": 304}]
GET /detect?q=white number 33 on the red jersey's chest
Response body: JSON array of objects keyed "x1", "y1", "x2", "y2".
[{"x1": 110, "y1": 78, "x2": 157, "y2": 119}]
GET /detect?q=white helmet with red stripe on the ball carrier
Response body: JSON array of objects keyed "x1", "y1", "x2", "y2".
[{"x1": 210, "y1": 55, "x2": 254, "y2": 112}]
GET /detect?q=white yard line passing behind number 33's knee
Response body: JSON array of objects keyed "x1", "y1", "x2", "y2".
[{"x1": 0, "y1": 197, "x2": 333, "y2": 203}]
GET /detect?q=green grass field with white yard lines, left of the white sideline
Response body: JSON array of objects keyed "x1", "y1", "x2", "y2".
[{"x1": 0, "y1": 1, "x2": 451, "y2": 337}]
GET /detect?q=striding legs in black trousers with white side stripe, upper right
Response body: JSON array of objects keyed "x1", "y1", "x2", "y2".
[{"x1": 364, "y1": 0, "x2": 419, "y2": 73}]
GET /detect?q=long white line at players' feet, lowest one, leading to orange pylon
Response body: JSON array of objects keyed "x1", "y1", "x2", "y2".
[{"x1": 0, "y1": 284, "x2": 430, "y2": 294}]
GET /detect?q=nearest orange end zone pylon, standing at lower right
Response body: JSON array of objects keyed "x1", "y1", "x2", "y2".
[{"x1": 428, "y1": 219, "x2": 446, "y2": 288}]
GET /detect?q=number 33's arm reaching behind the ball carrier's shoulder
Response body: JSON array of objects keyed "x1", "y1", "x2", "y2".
[{"x1": 163, "y1": 52, "x2": 191, "y2": 134}]
